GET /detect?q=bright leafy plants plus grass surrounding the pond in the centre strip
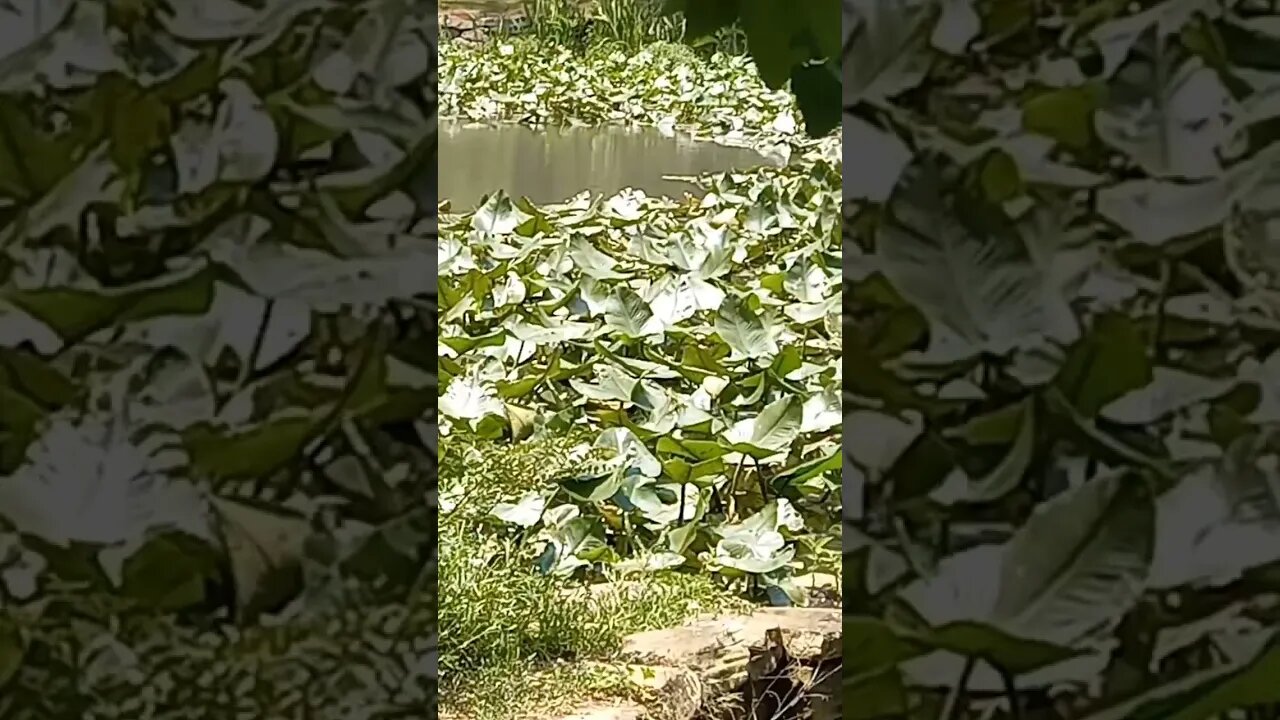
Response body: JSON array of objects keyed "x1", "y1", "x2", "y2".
[{"x1": 439, "y1": 7, "x2": 841, "y2": 717}]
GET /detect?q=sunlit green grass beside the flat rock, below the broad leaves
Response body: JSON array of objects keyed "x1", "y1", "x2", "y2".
[{"x1": 439, "y1": 430, "x2": 748, "y2": 720}]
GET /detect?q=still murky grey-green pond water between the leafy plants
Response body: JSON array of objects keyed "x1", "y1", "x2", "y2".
[{"x1": 439, "y1": 123, "x2": 778, "y2": 211}]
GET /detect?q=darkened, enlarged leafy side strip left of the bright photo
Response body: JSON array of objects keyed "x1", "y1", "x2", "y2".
[{"x1": 0, "y1": 0, "x2": 436, "y2": 720}]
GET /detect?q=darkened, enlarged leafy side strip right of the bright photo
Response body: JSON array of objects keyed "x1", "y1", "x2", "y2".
[{"x1": 844, "y1": 0, "x2": 1280, "y2": 720}]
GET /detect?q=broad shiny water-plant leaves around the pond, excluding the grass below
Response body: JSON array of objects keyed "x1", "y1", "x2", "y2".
[{"x1": 439, "y1": 37, "x2": 840, "y2": 602}]
